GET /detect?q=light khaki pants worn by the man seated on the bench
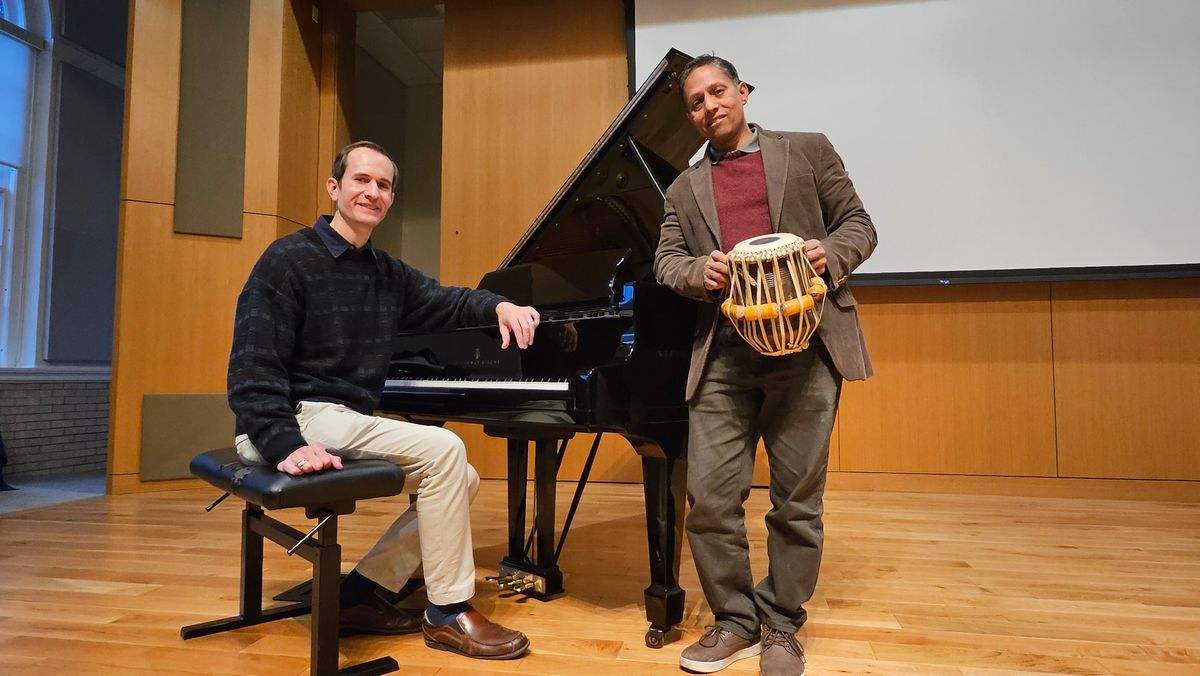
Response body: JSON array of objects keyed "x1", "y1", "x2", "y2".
[{"x1": 235, "y1": 401, "x2": 479, "y2": 605}]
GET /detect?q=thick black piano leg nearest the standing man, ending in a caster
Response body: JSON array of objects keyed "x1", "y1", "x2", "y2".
[{"x1": 642, "y1": 455, "x2": 688, "y2": 648}]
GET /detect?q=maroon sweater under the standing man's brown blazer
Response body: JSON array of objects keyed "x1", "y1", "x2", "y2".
[{"x1": 713, "y1": 150, "x2": 770, "y2": 252}]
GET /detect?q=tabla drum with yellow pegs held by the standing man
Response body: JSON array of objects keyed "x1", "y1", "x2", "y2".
[{"x1": 721, "y1": 233, "x2": 828, "y2": 357}]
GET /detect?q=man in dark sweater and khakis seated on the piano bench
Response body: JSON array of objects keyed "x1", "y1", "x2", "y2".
[{"x1": 229, "y1": 142, "x2": 538, "y2": 659}]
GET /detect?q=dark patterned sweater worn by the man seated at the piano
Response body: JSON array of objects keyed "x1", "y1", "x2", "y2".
[{"x1": 228, "y1": 216, "x2": 504, "y2": 463}]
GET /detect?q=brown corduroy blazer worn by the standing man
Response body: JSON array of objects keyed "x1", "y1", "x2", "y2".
[{"x1": 654, "y1": 128, "x2": 876, "y2": 400}]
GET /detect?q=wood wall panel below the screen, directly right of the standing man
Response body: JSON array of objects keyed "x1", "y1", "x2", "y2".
[{"x1": 840, "y1": 285, "x2": 1056, "y2": 477}]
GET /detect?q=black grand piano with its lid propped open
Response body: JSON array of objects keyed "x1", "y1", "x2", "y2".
[{"x1": 379, "y1": 49, "x2": 703, "y2": 647}]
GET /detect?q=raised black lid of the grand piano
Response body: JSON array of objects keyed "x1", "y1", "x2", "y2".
[{"x1": 494, "y1": 49, "x2": 704, "y2": 274}]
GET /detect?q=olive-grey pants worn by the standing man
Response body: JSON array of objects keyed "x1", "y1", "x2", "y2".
[{"x1": 686, "y1": 325, "x2": 841, "y2": 639}]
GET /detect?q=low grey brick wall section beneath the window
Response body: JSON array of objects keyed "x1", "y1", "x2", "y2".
[{"x1": 0, "y1": 381, "x2": 109, "y2": 479}]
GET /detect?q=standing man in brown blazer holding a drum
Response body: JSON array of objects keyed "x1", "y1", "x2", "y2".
[{"x1": 654, "y1": 55, "x2": 876, "y2": 676}]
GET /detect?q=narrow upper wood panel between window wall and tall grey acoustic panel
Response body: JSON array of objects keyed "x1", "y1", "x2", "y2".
[{"x1": 121, "y1": 0, "x2": 182, "y2": 204}]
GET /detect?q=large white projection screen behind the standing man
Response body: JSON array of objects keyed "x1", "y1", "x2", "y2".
[{"x1": 634, "y1": 0, "x2": 1200, "y2": 283}]
